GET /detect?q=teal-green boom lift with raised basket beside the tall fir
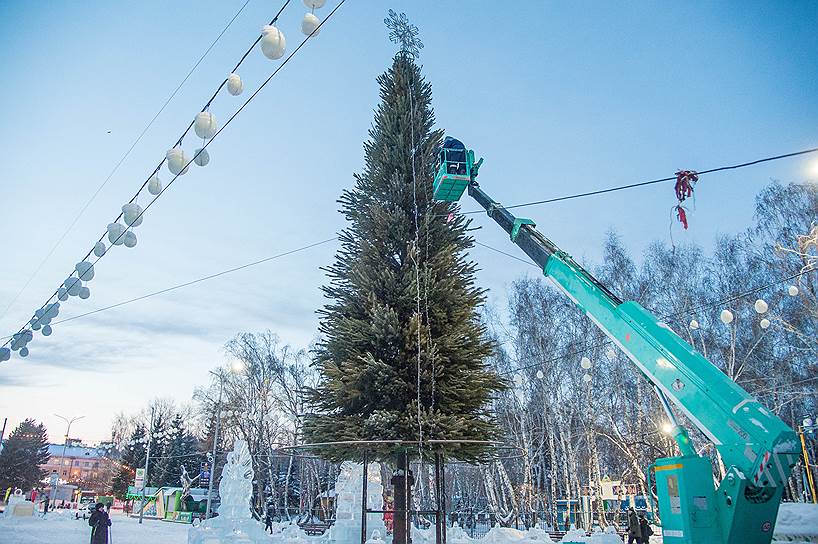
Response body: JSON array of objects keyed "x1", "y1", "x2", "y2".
[{"x1": 434, "y1": 138, "x2": 799, "y2": 544}]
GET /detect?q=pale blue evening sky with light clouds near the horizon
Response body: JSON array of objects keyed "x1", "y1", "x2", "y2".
[{"x1": 0, "y1": 0, "x2": 818, "y2": 442}]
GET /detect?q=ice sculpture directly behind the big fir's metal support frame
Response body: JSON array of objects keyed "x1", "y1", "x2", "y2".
[{"x1": 329, "y1": 462, "x2": 392, "y2": 544}]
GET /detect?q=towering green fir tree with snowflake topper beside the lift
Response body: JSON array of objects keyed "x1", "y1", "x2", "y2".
[{"x1": 304, "y1": 12, "x2": 503, "y2": 460}]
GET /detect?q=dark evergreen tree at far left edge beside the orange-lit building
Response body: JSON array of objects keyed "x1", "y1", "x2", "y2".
[{"x1": 0, "y1": 419, "x2": 50, "y2": 491}]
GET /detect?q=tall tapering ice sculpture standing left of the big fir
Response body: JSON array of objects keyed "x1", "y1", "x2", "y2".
[{"x1": 187, "y1": 440, "x2": 270, "y2": 544}]
